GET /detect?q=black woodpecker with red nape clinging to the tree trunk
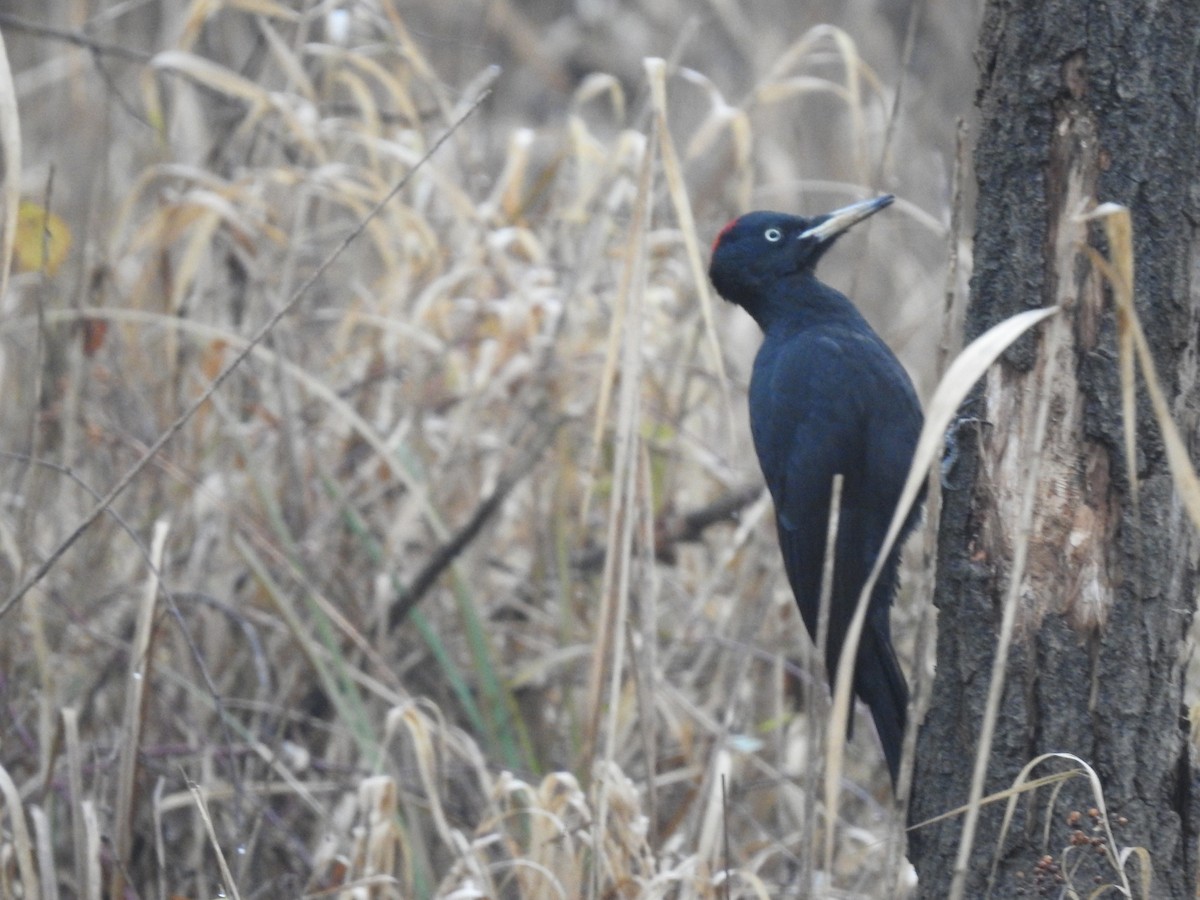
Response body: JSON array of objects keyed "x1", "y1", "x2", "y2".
[{"x1": 708, "y1": 194, "x2": 924, "y2": 787}]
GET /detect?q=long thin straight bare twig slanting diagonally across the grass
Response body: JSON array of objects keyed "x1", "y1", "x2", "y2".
[{"x1": 0, "y1": 90, "x2": 491, "y2": 619}]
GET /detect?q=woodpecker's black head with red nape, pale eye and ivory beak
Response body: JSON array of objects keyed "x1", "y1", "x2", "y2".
[{"x1": 708, "y1": 194, "x2": 895, "y2": 306}]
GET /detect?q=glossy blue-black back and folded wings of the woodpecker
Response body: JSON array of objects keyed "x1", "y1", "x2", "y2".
[{"x1": 750, "y1": 329, "x2": 920, "y2": 666}]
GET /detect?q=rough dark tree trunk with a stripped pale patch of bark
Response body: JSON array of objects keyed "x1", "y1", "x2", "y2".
[{"x1": 910, "y1": 0, "x2": 1200, "y2": 900}]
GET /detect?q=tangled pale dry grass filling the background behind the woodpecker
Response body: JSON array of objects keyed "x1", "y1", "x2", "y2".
[{"x1": 0, "y1": 0, "x2": 970, "y2": 898}]
